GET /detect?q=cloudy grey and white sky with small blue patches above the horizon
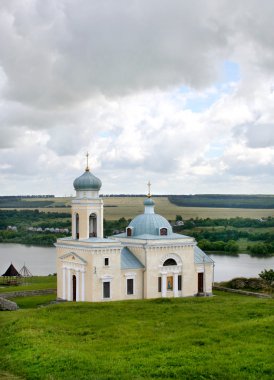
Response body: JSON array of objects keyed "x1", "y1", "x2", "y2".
[{"x1": 0, "y1": 0, "x2": 274, "y2": 196}]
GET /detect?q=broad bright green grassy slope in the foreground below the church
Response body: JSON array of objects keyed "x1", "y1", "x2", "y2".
[{"x1": 0, "y1": 292, "x2": 274, "y2": 380}]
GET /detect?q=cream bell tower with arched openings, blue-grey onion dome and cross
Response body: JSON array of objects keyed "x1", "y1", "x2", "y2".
[{"x1": 71, "y1": 153, "x2": 104, "y2": 240}]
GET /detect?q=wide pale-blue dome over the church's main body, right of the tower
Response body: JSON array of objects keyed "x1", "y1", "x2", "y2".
[{"x1": 128, "y1": 212, "x2": 172, "y2": 236}]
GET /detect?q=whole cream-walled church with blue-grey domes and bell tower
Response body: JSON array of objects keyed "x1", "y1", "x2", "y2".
[{"x1": 55, "y1": 159, "x2": 214, "y2": 302}]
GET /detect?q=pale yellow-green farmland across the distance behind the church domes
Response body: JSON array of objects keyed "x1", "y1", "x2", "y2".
[{"x1": 1, "y1": 197, "x2": 274, "y2": 220}]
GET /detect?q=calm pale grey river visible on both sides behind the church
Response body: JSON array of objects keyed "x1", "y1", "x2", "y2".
[{"x1": 0, "y1": 243, "x2": 274, "y2": 282}]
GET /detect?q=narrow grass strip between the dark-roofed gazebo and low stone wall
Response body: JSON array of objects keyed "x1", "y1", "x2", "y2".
[{"x1": 0, "y1": 276, "x2": 57, "y2": 293}]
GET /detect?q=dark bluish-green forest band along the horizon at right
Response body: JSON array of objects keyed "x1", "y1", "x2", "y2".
[{"x1": 168, "y1": 194, "x2": 274, "y2": 209}]
